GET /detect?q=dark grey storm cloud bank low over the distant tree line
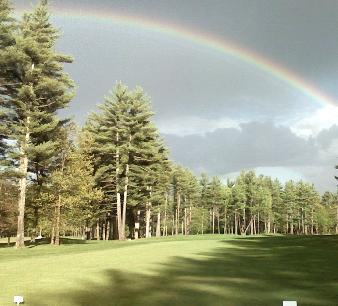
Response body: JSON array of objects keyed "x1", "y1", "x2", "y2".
[{"x1": 165, "y1": 122, "x2": 338, "y2": 190}]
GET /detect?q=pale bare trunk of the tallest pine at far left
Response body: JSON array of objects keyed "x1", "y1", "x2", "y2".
[{"x1": 15, "y1": 117, "x2": 30, "y2": 248}]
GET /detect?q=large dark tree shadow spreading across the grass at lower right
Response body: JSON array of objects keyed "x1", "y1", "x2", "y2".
[{"x1": 32, "y1": 236, "x2": 338, "y2": 306}]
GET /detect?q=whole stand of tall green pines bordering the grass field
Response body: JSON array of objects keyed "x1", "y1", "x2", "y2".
[{"x1": 0, "y1": 0, "x2": 338, "y2": 248}]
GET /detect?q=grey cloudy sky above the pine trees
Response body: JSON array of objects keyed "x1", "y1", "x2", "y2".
[{"x1": 14, "y1": 0, "x2": 338, "y2": 192}]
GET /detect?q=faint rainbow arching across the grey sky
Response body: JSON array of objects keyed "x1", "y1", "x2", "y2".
[{"x1": 17, "y1": 7, "x2": 338, "y2": 106}]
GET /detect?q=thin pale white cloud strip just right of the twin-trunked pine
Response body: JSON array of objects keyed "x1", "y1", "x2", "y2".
[{"x1": 157, "y1": 116, "x2": 241, "y2": 136}]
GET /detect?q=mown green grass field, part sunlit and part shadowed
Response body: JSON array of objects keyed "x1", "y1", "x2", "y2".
[{"x1": 0, "y1": 235, "x2": 338, "y2": 306}]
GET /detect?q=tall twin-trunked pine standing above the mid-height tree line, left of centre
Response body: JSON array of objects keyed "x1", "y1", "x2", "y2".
[{"x1": 86, "y1": 83, "x2": 167, "y2": 240}]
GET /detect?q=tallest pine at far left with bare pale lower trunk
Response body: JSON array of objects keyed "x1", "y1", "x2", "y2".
[{"x1": 2, "y1": 0, "x2": 73, "y2": 248}]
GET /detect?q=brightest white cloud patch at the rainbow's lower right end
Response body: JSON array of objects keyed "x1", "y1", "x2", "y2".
[{"x1": 290, "y1": 105, "x2": 338, "y2": 138}]
